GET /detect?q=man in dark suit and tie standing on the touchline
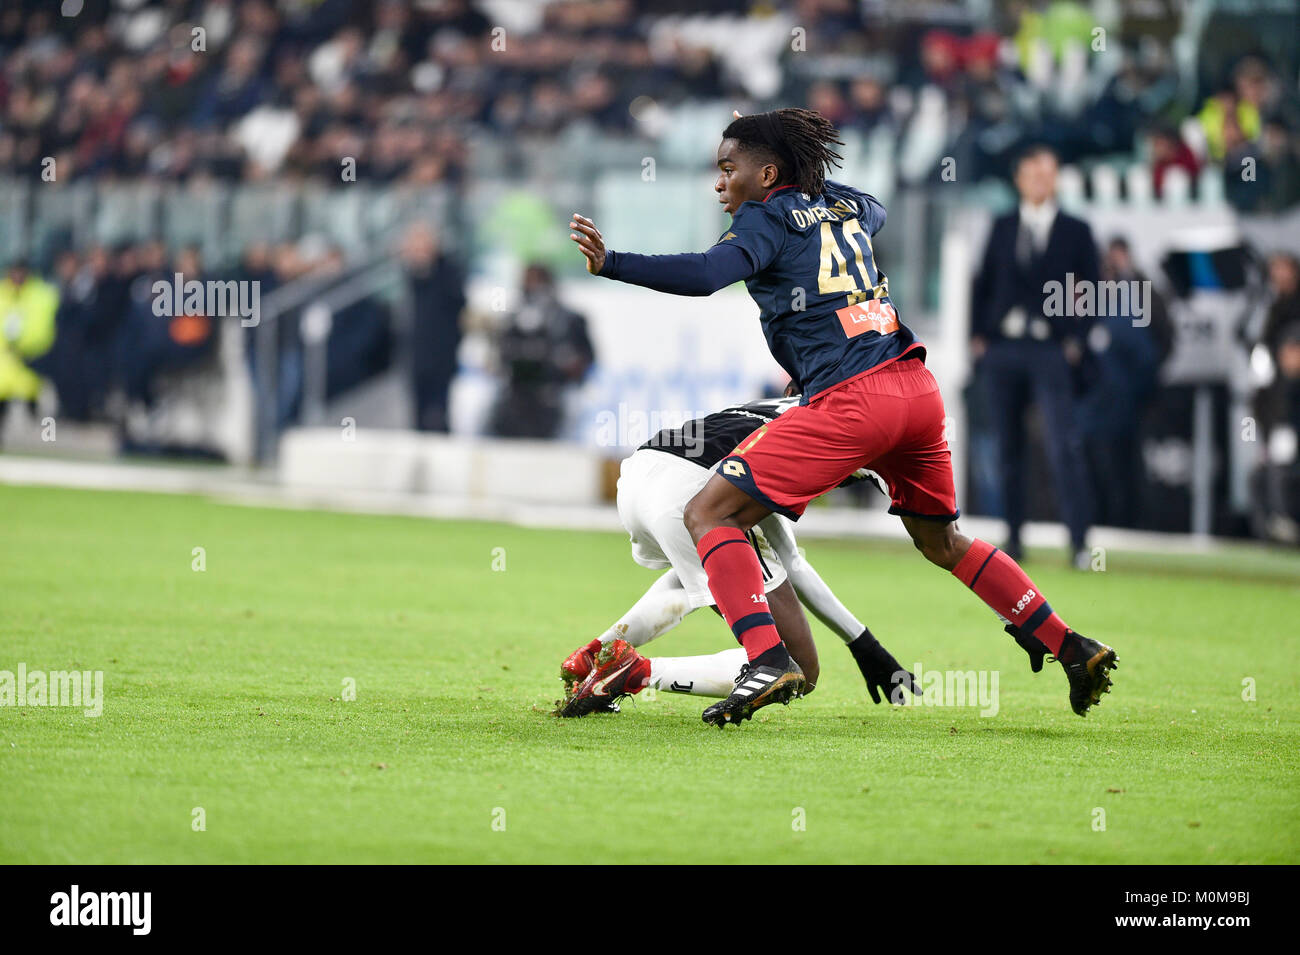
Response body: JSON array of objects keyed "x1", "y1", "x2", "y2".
[{"x1": 971, "y1": 146, "x2": 1099, "y2": 569}]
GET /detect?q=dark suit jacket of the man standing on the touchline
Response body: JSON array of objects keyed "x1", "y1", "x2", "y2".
[{"x1": 971, "y1": 209, "x2": 1100, "y2": 342}]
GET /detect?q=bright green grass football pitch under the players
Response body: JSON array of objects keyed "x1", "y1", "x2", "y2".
[{"x1": 0, "y1": 487, "x2": 1300, "y2": 863}]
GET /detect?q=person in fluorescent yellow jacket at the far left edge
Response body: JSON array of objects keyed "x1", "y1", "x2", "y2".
[{"x1": 0, "y1": 260, "x2": 59, "y2": 401}]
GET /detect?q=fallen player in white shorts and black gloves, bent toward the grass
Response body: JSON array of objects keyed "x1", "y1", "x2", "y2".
[{"x1": 556, "y1": 398, "x2": 915, "y2": 716}]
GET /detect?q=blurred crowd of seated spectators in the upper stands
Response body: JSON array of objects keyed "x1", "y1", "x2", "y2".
[{"x1": 0, "y1": 0, "x2": 1300, "y2": 200}]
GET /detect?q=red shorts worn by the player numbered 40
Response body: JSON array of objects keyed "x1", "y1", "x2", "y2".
[{"x1": 718, "y1": 359, "x2": 958, "y2": 521}]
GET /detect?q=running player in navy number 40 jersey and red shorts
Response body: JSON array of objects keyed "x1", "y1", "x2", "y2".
[{"x1": 569, "y1": 109, "x2": 1117, "y2": 726}]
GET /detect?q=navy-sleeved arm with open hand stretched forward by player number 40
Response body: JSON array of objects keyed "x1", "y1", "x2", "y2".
[{"x1": 569, "y1": 213, "x2": 754, "y2": 295}]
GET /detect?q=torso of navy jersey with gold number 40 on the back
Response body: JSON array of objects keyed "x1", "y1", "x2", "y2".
[{"x1": 718, "y1": 181, "x2": 924, "y2": 401}]
